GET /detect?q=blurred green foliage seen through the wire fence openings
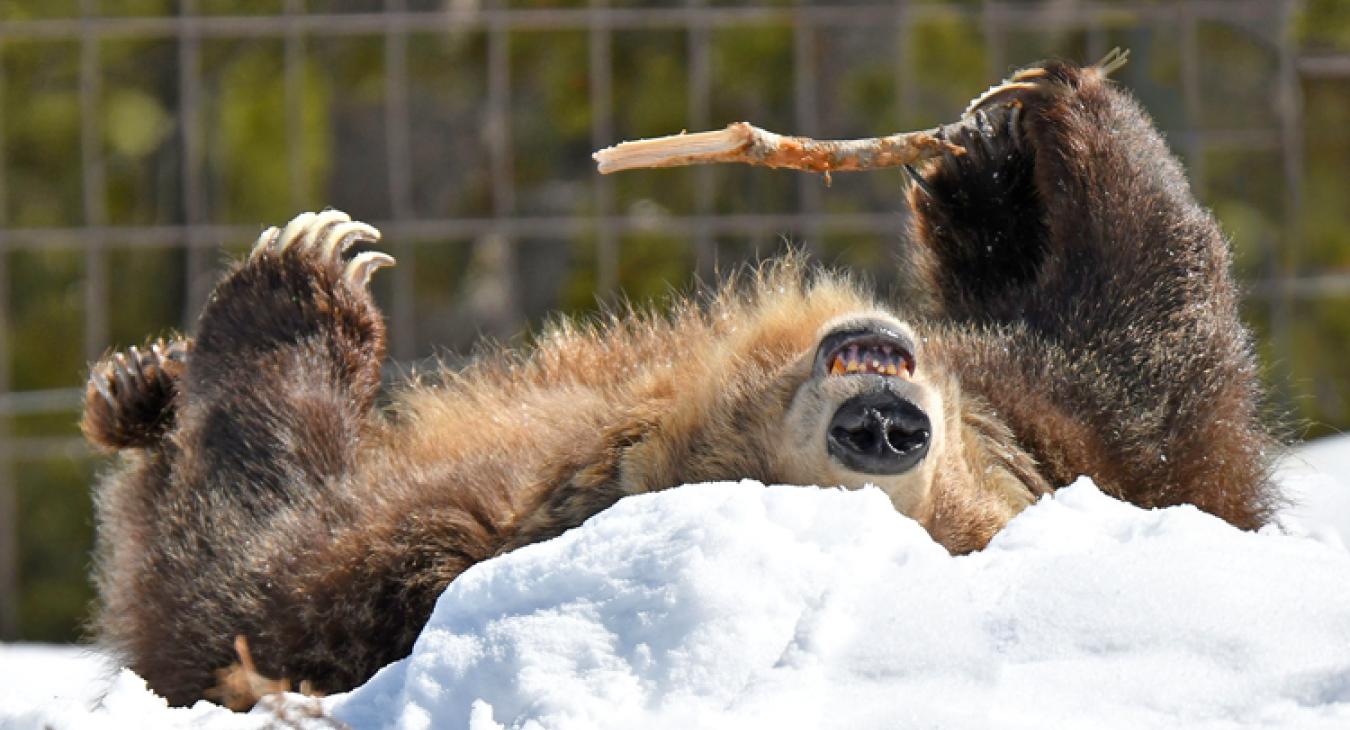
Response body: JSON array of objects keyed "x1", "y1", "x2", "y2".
[{"x1": 0, "y1": 0, "x2": 1350, "y2": 641}]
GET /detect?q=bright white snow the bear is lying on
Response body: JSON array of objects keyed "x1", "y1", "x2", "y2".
[{"x1": 0, "y1": 437, "x2": 1350, "y2": 730}]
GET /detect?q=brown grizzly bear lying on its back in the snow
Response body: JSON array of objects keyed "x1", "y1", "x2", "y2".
[{"x1": 82, "y1": 62, "x2": 1274, "y2": 704}]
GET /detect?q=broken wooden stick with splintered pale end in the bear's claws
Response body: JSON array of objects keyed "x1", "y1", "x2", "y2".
[{"x1": 591, "y1": 121, "x2": 965, "y2": 175}]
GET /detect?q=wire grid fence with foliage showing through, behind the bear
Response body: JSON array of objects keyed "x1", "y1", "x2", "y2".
[{"x1": 0, "y1": 0, "x2": 1350, "y2": 638}]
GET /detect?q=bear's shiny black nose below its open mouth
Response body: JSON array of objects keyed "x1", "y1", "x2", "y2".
[{"x1": 825, "y1": 390, "x2": 933, "y2": 474}]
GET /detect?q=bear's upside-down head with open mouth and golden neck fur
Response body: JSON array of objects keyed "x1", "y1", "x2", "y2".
[{"x1": 615, "y1": 267, "x2": 1049, "y2": 552}]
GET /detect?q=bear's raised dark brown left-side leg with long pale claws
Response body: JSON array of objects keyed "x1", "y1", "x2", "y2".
[{"x1": 181, "y1": 210, "x2": 394, "y2": 499}]
